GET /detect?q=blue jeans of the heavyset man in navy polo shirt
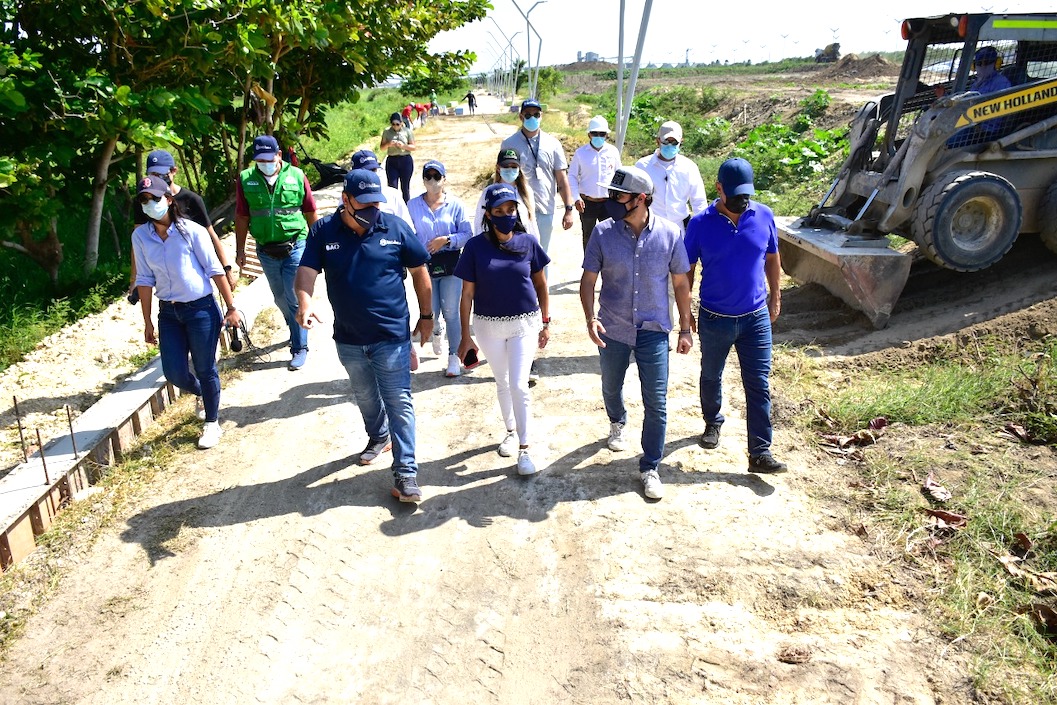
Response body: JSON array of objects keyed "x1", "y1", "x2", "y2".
[{"x1": 337, "y1": 340, "x2": 419, "y2": 478}]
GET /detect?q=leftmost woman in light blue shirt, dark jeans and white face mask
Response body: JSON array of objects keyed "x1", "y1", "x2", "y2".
[{"x1": 132, "y1": 175, "x2": 241, "y2": 448}]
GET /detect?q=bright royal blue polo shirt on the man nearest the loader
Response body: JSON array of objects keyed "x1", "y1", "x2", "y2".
[{"x1": 684, "y1": 201, "x2": 778, "y2": 316}]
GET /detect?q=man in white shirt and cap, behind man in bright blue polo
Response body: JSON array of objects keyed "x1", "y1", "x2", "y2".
[{"x1": 635, "y1": 120, "x2": 708, "y2": 233}]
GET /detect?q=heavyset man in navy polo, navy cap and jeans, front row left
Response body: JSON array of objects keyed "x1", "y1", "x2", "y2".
[{"x1": 294, "y1": 169, "x2": 433, "y2": 502}]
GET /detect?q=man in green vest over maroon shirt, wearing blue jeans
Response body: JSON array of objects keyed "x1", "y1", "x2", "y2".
[{"x1": 235, "y1": 134, "x2": 316, "y2": 370}]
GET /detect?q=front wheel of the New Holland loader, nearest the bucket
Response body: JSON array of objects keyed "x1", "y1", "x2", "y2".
[{"x1": 911, "y1": 171, "x2": 1023, "y2": 272}]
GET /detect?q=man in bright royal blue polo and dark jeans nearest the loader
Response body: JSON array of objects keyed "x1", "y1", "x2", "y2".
[{"x1": 685, "y1": 159, "x2": 785, "y2": 472}]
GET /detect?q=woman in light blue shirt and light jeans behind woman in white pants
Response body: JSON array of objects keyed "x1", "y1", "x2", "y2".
[{"x1": 407, "y1": 161, "x2": 474, "y2": 377}]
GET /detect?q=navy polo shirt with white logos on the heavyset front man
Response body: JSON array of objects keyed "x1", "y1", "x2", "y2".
[{"x1": 301, "y1": 208, "x2": 429, "y2": 346}]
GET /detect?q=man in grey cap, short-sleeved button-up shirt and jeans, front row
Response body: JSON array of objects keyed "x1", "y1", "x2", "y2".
[{"x1": 580, "y1": 167, "x2": 693, "y2": 499}]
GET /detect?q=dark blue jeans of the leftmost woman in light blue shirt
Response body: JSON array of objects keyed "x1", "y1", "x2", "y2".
[{"x1": 157, "y1": 295, "x2": 223, "y2": 421}]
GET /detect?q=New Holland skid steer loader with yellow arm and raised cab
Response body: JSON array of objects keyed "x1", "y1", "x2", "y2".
[{"x1": 779, "y1": 14, "x2": 1057, "y2": 329}]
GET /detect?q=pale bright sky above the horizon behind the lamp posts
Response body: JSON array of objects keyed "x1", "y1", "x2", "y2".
[{"x1": 430, "y1": 0, "x2": 1040, "y2": 73}]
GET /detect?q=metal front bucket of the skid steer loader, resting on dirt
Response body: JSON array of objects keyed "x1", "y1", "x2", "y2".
[{"x1": 775, "y1": 218, "x2": 911, "y2": 329}]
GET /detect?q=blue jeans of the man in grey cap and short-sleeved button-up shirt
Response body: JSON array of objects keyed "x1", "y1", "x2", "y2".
[{"x1": 598, "y1": 331, "x2": 668, "y2": 472}]
